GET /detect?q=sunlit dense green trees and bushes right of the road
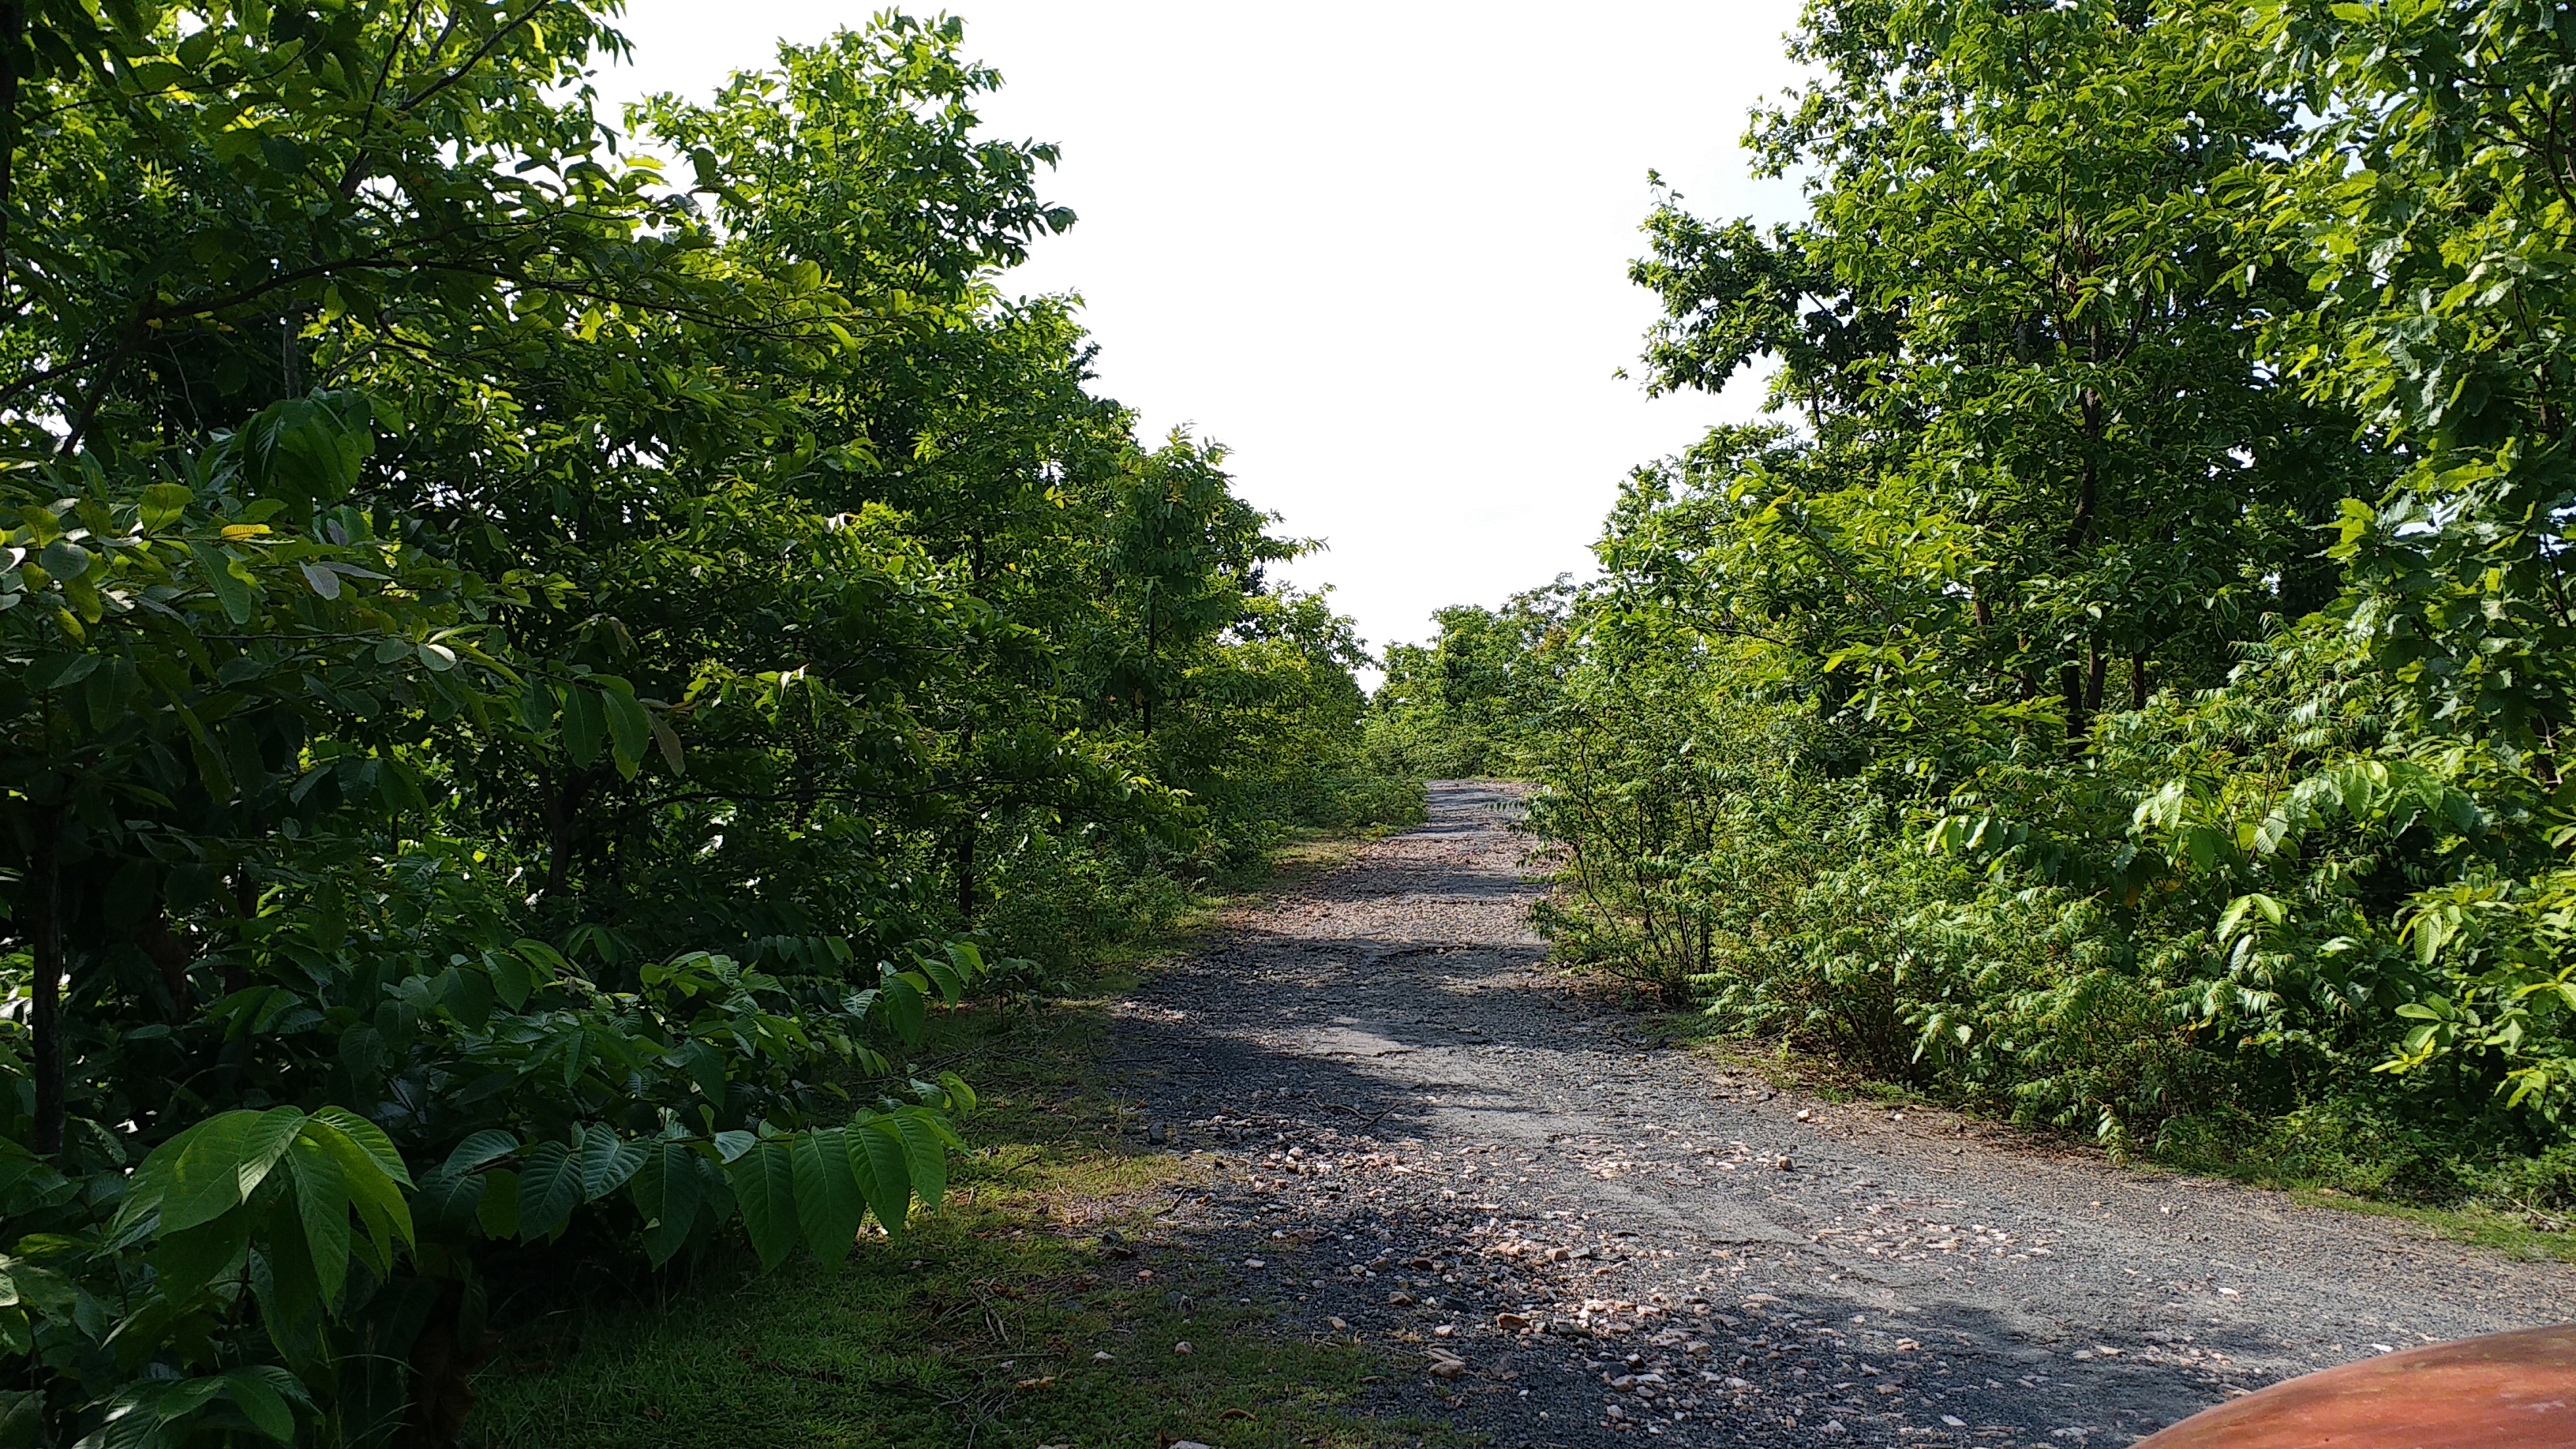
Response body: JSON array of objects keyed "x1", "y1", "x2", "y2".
[{"x1": 1373, "y1": 0, "x2": 2576, "y2": 1201}]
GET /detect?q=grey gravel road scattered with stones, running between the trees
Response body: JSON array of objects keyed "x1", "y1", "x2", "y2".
[{"x1": 1121, "y1": 784, "x2": 2576, "y2": 1449}]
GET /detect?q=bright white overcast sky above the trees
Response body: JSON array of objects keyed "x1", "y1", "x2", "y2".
[{"x1": 597, "y1": 0, "x2": 1798, "y2": 647}]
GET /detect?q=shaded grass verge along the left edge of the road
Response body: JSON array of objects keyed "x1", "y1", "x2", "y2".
[{"x1": 466, "y1": 838, "x2": 1445, "y2": 1449}]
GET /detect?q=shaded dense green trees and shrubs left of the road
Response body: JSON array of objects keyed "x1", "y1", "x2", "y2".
[{"x1": 0, "y1": 0, "x2": 1402, "y2": 1447}]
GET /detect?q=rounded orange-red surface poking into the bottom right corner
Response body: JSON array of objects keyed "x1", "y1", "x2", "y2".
[{"x1": 2136, "y1": 1323, "x2": 2576, "y2": 1449}]
